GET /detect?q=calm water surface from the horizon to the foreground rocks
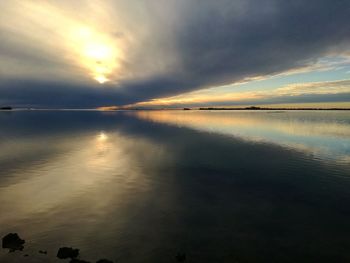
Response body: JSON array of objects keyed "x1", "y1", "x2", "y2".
[{"x1": 0, "y1": 111, "x2": 350, "y2": 263}]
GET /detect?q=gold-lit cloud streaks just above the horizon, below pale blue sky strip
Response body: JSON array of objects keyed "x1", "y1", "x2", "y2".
[{"x1": 135, "y1": 80, "x2": 350, "y2": 107}]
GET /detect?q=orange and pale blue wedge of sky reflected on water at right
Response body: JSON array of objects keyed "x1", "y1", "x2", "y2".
[{"x1": 133, "y1": 111, "x2": 350, "y2": 164}]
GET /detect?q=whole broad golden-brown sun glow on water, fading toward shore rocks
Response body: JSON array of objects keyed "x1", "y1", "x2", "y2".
[{"x1": 0, "y1": 116, "x2": 170, "y2": 262}]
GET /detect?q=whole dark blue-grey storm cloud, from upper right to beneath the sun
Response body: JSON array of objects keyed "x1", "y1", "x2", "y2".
[{"x1": 0, "y1": 0, "x2": 350, "y2": 107}]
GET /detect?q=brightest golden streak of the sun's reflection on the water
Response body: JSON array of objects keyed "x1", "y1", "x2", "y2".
[{"x1": 0, "y1": 134, "x2": 152, "y2": 225}]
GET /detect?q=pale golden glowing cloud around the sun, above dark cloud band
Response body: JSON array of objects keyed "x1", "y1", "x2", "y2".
[{"x1": 0, "y1": 0, "x2": 179, "y2": 88}]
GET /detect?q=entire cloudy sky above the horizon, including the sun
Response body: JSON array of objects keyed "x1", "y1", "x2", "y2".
[{"x1": 0, "y1": 0, "x2": 350, "y2": 108}]
